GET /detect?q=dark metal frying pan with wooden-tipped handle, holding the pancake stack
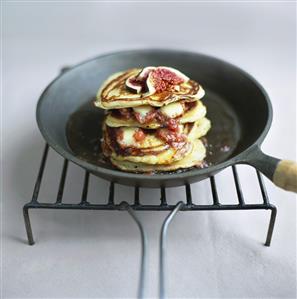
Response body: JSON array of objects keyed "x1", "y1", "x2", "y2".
[{"x1": 36, "y1": 49, "x2": 297, "y2": 192}]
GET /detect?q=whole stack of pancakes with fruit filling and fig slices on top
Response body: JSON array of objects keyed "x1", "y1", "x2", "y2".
[{"x1": 95, "y1": 67, "x2": 211, "y2": 172}]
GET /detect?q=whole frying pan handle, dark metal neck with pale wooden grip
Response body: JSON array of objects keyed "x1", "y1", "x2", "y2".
[{"x1": 245, "y1": 147, "x2": 297, "y2": 193}]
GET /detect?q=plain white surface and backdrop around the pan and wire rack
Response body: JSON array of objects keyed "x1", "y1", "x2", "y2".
[{"x1": 2, "y1": 1, "x2": 296, "y2": 298}]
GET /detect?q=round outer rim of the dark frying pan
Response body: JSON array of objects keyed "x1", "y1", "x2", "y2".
[{"x1": 36, "y1": 48, "x2": 273, "y2": 181}]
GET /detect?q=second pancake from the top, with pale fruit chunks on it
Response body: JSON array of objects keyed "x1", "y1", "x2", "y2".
[{"x1": 106, "y1": 101, "x2": 206, "y2": 129}]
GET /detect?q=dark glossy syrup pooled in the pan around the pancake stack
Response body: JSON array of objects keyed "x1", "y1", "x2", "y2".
[{"x1": 66, "y1": 91, "x2": 240, "y2": 172}]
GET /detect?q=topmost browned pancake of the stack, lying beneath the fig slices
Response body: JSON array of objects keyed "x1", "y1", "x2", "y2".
[{"x1": 95, "y1": 68, "x2": 205, "y2": 109}]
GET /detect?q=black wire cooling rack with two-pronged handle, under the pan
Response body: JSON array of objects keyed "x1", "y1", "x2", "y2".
[{"x1": 23, "y1": 144, "x2": 277, "y2": 298}]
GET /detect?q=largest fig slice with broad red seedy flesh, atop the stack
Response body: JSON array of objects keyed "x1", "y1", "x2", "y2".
[{"x1": 146, "y1": 66, "x2": 189, "y2": 94}]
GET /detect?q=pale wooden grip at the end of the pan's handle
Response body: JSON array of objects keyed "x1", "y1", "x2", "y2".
[{"x1": 273, "y1": 160, "x2": 297, "y2": 193}]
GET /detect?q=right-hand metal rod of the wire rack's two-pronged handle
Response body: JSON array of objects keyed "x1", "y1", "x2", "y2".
[{"x1": 159, "y1": 201, "x2": 184, "y2": 299}]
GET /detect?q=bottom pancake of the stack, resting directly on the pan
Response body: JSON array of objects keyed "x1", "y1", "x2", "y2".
[{"x1": 110, "y1": 139, "x2": 206, "y2": 173}]
